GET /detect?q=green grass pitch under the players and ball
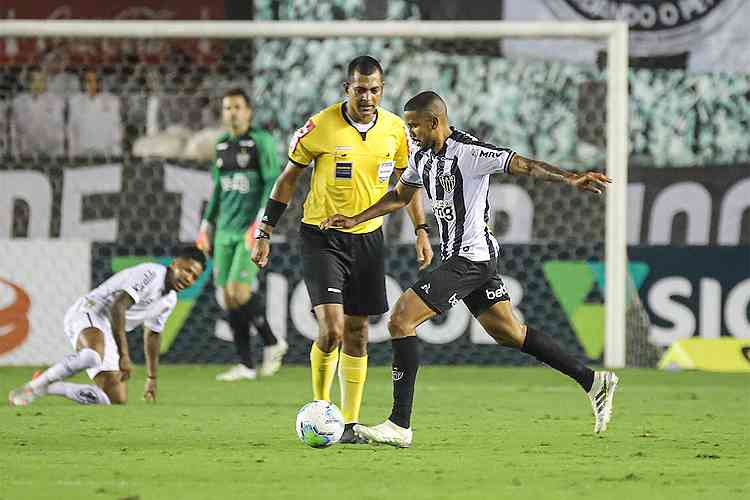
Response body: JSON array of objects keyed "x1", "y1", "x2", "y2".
[{"x1": 0, "y1": 366, "x2": 750, "y2": 500}]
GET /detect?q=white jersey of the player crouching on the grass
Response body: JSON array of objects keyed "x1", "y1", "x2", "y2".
[{"x1": 84, "y1": 263, "x2": 177, "y2": 332}]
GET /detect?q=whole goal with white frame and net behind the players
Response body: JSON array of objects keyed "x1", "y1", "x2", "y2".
[{"x1": 0, "y1": 14, "x2": 651, "y2": 367}]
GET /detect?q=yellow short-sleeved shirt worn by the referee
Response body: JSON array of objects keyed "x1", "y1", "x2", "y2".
[{"x1": 289, "y1": 102, "x2": 409, "y2": 234}]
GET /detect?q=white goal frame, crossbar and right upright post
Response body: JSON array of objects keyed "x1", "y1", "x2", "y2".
[{"x1": 0, "y1": 20, "x2": 628, "y2": 368}]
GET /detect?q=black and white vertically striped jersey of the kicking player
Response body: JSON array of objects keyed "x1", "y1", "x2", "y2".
[{"x1": 401, "y1": 129, "x2": 515, "y2": 262}]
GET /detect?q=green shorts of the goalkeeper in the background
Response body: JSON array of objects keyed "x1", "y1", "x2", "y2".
[{"x1": 214, "y1": 231, "x2": 259, "y2": 287}]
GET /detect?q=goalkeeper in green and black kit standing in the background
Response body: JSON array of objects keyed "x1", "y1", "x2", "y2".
[{"x1": 196, "y1": 89, "x2": 288, "y2": 381}]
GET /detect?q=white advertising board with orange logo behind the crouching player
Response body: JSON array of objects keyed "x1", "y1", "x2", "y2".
[{"x1": 0, "y1": 239, "x2": 91, "y2": 365}]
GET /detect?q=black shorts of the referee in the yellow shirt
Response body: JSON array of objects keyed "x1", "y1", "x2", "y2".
[{"x1": 300, "y1": 224, "x2": 388, "y2": 316}]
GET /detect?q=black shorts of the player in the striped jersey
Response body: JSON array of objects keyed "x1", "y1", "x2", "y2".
[{"x1": 411, "y1": 256, "x2": 510, "y2": 316}]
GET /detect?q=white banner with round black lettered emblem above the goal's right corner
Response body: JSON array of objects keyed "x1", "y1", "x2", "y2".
[{"x1": 503, "y1": 0, "x2": 750, "y2": 73}]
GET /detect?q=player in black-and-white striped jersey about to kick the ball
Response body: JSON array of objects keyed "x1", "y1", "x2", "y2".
[{"x1": 320, "y1": 92, "x2": 618, "y2": 447}]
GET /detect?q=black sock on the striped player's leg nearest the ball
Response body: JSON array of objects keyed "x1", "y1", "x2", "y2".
[{"x1": 388, "y1": 335, "x2": 419, "y2": 429}]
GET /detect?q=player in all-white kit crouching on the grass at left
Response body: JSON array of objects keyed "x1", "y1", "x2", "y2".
[{"x1": 8, "y1": 247, "x2": 206, "y2": 406}]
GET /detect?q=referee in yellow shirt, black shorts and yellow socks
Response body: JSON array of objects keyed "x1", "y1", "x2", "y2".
[{"x1": 252, "y1": 56, "x2": 432, "y2": 443}]
